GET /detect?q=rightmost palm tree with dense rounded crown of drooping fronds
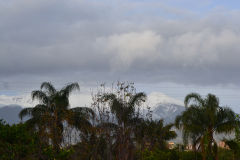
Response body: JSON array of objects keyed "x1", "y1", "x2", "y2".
[{"x1": 175, "y1": 93, "x2": 236, "y2": 160}]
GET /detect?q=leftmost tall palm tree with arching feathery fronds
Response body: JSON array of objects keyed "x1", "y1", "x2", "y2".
[{"x1": 19, "y1": 82, "x2": 94, "y2": 152}]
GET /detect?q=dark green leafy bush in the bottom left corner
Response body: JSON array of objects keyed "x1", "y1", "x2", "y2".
[{"x1": 0, "y1": 121, "x2": 37, "y2": 160}]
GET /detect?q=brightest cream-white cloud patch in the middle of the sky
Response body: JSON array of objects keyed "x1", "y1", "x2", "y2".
[{"x1": 96, "y1": 31, "x2": 162, "y2": 70}]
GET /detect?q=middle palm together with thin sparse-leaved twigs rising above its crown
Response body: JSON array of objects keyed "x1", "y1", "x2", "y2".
[{"x1": 97, "y1": 83, "x2": 146, "y2": 159}]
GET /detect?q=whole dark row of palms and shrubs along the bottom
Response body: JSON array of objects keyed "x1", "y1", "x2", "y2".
[{"x1": 0, "y1": 82, "x2": 240, "y2": 160}]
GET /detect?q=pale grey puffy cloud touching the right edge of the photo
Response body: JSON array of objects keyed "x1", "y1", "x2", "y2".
[{"x1": 166, "y1": 29, "x2": 240, "y2": 67}]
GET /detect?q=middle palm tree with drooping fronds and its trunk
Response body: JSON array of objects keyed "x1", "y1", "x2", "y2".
[{"x1": 103, "y1": 92, "x2": 146, "y2": 160}]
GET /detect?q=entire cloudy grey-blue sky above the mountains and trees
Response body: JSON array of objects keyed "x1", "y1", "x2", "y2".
[{"x1": 0, "y1": 0, "x2": 240, "y2": 113}]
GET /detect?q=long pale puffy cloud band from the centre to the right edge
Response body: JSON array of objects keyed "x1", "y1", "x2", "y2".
[{"x1": 96, "y1": 28, "x2": 240, "y2": 70}]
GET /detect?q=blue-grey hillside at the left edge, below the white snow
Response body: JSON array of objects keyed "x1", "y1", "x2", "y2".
[{"x1": 0, "y1": 105, "x2": 23, "y2": 125}]
